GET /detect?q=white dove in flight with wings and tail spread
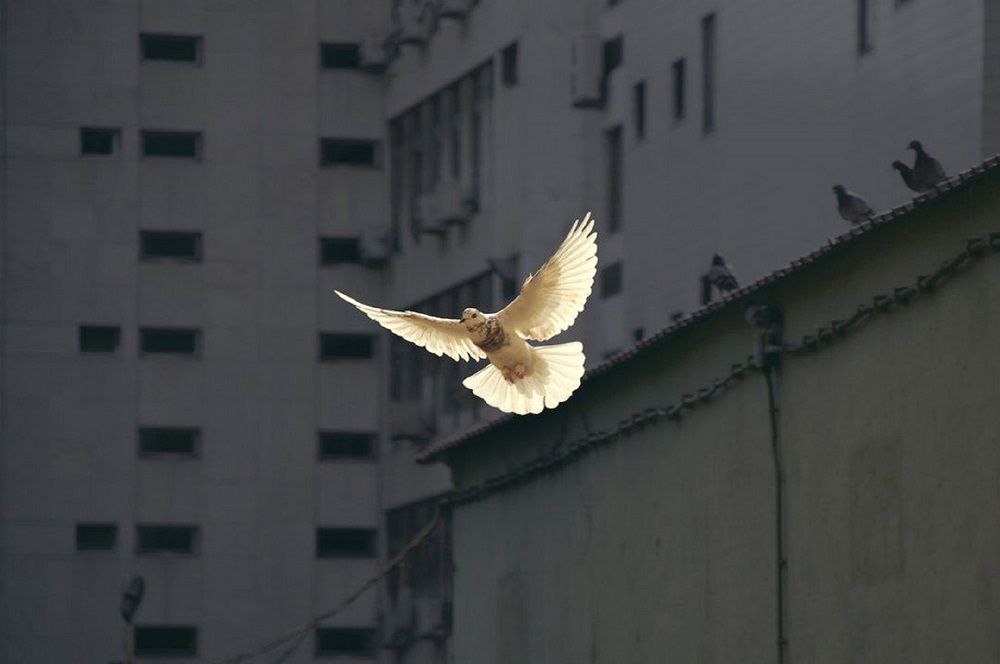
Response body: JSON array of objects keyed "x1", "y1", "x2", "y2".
[{"x1": 334, "y1": 212, "x2": 597, "y2": 415}]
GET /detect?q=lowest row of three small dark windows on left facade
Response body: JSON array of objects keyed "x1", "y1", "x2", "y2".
[{"x1": 75, "y1": 522, "x2": 377, "y2": 558}]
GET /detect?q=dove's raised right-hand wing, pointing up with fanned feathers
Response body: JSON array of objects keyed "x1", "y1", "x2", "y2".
[{"x1": 496, "y1": 212, "x2": 597, "y2": 341}]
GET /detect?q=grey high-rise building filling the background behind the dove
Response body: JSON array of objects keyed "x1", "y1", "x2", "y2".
[{"x1": 0, "y1": 0, "x2": 1000, "y2": 664}]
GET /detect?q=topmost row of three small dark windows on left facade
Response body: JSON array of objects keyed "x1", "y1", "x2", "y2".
[{"x1": 80, "y1": 127, "x2": 382, "y2": 167}]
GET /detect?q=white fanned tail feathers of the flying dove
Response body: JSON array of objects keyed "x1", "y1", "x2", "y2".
[{"x1": 462, "y1": 341, "x2": 585, "y2": 415}]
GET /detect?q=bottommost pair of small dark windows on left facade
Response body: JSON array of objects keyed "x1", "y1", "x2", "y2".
[{"x1": 106, "y1": 625, "x2": 377, "y2": 658}]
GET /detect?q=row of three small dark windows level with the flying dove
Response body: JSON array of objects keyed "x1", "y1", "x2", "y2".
[{"x1": 78, "y1": 325, "x2": 376, "y2": 362}]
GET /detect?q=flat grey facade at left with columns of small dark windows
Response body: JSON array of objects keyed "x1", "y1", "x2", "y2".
[{"x1": 0, "y1": 0, "x2": 386, "y2": 663}]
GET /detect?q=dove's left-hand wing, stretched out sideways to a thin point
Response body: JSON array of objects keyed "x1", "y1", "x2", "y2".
[{"x1": 334, "y1": 291, "x2": 486, "y2": 360}]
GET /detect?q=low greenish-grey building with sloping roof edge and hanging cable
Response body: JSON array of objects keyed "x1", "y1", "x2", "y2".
[{"x1": 426, "y1": 158, "x2": 1000, "y2": 664}]
